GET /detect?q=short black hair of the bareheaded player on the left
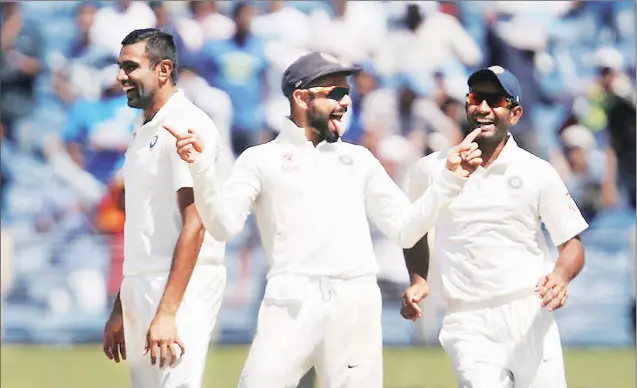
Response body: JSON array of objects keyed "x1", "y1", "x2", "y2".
[{"x1": 122, "y1": 28, "x2": 179, "y2": 84}]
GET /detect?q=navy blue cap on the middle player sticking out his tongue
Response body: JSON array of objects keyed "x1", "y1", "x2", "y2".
[{"x1": 281, "y1": 52, "x2": 362, "y2": 98}]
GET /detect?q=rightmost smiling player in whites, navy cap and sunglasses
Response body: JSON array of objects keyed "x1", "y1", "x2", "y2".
[{"x1": 401, "y1": 66, "x2": 588, "y2": 388}]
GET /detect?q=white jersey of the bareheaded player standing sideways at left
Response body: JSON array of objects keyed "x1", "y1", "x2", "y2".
[{"x1": 123, "y1": 90, "x2": 225, "y2": 276}]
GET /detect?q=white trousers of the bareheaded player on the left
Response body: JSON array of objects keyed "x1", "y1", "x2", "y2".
[{"x1": 120, "y1": 265, "x2": 226, "y2": 388}]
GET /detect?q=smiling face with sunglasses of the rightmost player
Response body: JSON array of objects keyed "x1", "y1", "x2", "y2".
[{"x1": 465, "y1": 81, "x2": 522, "y2": 143}]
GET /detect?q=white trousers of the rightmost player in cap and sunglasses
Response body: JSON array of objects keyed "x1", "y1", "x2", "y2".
[{"x1": 439, "y1": 291, "x2": 566, "y2": 388}]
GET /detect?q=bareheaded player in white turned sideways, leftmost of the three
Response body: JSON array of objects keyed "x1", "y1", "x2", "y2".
[{"x1": 104, "y1": 29, "x2": 226, "y2": 388}]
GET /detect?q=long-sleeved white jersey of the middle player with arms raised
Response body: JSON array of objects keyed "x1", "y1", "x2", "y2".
[{"x1": 190, "y1": 119, "x2": 466, "y2": 278}]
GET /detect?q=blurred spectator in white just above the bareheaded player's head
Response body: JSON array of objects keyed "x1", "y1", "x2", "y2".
[{"x1": 90, "y1": 0, "x2": 157, "y2": 57}]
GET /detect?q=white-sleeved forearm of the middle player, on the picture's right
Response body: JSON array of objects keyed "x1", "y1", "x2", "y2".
[{"x1": 396, "y1": 169, "x2": 466, "y2": 248}]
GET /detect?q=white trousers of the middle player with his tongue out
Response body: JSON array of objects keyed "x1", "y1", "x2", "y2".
[{"x1": 239, "y1": 276, "x2": 383, "y2": 388}]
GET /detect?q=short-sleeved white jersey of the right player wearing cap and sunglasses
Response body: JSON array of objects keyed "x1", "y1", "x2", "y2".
[{"x1": 409, "y1": 136, "x2": 588, "y2": 302}]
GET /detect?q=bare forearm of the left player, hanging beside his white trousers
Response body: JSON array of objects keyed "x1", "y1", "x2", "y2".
[{"x1": 157, "y1": 228, "x2": 205, "y2": 315}]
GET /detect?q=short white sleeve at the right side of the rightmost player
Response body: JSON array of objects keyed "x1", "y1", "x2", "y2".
[{"x1": 539, "y1": 165, "x2": 588, "y2": 247}]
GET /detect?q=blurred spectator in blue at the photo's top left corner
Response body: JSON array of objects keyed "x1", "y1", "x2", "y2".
[{"x1": 0, "y1": 1, "x2": 44, "y2": 140}]
